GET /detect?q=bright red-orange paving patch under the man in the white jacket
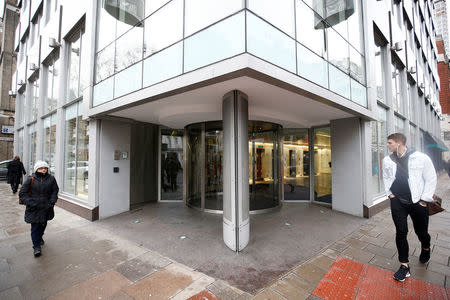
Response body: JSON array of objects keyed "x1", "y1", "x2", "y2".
[{"x1": 313, "y1": 257, "x2": 450, "y2": 300}]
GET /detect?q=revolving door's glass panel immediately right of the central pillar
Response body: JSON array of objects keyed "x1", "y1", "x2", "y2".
[{"x1": 248, "y1": 121, "x2": 280, "y2": 211}]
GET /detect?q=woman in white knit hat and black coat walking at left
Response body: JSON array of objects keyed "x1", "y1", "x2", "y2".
[{"x1": 19, "y1": 161, "x2": 59, "y2": 257}]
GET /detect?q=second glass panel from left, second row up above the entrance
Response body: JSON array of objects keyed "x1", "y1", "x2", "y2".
[{"x1": 115, "y1": 27, "x2": 144, "y2": 72}]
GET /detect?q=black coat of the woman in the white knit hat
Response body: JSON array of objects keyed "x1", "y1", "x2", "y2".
[{"x1": 19, "y1": 173, "x2": 59, "y2": 223}]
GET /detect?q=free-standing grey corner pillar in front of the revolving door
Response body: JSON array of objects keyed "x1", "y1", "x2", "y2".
[{"x1": 222, "y1": 90, "x2": 250, "y2": 252}]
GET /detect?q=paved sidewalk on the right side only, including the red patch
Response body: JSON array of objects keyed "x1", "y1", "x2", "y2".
[{"x1": 254, "y1": 174, "x2": 450, "y2": 300}]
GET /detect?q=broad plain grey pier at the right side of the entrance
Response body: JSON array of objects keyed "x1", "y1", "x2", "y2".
[{"x1": 330, "y1": 118, "x2": 367, "y2": 217}]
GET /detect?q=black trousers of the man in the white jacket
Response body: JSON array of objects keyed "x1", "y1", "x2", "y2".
[{"x1": 391, "y1": 198, "x2": 430, "y2": 263}]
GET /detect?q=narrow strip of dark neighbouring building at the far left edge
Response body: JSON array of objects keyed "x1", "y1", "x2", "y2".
[{"x1": 0, "y1": 0, "x2": 19, "y2": 162}]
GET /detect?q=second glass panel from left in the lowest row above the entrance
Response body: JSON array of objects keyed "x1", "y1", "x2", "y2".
[{"x1": 114, "y1": 62, "x2": 142, "y2": 98}]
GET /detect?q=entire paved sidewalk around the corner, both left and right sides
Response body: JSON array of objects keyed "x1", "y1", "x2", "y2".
[{"x1": 0, "y1": 174, "x2": 450, "y2": 300}]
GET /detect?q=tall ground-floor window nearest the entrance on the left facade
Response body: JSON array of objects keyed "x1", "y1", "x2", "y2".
[{"x1": 63, "y1": 101, "x2": 89, "y2": 199}]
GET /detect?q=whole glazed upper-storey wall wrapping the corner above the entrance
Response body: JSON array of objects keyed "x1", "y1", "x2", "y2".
[{"x1": 93, "y1": 0, "x2": 367, "y2": 107}]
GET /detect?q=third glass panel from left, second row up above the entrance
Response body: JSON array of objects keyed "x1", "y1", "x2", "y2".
[{"x1": 144, "y1": 0, "x2": 183, "y2": 57}]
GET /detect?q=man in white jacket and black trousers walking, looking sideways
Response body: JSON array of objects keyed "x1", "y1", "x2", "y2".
[{"x1": 383, "y1": 133, "x2": 436, "y2": 281}]
